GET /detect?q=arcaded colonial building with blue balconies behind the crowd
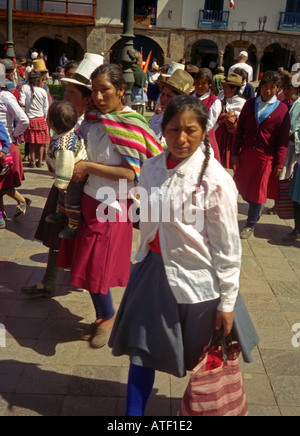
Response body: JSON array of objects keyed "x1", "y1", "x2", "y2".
[{"x1": 0, "y1": 0, "x2": 300, "y2": 78}]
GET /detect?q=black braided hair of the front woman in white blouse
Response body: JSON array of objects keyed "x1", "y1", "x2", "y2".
[{"x1": 162, "y1": 94, "x2": 211, "y2": 184}]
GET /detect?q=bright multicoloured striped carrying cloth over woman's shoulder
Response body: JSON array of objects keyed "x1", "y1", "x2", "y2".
[{"x1": 85, "y1": 105, "x2": 164, "y2": 182}]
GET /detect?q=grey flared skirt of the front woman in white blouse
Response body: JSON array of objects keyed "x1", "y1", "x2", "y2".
[{"x1": 109, "y1": 251, "x2": 259, "y2": 377}]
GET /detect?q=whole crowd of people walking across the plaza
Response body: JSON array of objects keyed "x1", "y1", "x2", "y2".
[{"x1": 0, "y1": 46, "x2": 300, "y2": 416}]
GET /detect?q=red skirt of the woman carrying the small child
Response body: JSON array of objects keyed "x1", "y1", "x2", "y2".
[{"x1": 57, "y1": 194, "x2": 132, "y2": 294}]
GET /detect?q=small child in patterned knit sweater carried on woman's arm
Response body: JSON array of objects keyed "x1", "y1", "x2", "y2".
[{"x1": 46, "y1": 101, "x2": 87, "y2": 239}]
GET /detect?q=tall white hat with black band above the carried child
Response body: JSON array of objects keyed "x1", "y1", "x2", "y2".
[{"x1": 61, "y1": 53, "x2": 104, "y2": 89}]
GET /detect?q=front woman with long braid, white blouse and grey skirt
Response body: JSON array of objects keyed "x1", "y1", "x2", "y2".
[{"x1": 109, "y1": 95, "x2": 258, "y2": 416}]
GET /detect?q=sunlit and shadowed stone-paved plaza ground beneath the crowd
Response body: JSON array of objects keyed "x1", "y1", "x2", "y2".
[{"x1": 0, "y1": 168, "x2": 300, "y2": 416}]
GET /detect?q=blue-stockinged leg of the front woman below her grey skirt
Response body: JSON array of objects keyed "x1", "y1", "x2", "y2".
[{"x1": 126, "y1": 363, "x2": 155, "y2": 416}]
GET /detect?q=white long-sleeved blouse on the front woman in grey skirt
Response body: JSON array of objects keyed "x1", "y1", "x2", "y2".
[{"x1": 137, "y1": 147, "x2": 241, "y2": 312}]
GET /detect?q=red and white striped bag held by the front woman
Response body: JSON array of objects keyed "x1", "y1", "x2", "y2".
[{"x1": 178, "y1": 332, "x2": 248, "y2": 416}]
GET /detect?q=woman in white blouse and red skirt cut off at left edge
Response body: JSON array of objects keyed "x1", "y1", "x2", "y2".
[{"x1": 0, "y1": 66, "x2": 31, "y2": 223}]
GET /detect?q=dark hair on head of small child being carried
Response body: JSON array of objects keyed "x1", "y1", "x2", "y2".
[{"x1": 48, "y1": 100, "x2": 78, "y2": 132}]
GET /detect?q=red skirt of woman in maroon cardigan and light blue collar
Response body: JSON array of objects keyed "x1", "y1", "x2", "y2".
[{"x1": 234, "y1": 148, "x2": 279, "y2": 204}]
